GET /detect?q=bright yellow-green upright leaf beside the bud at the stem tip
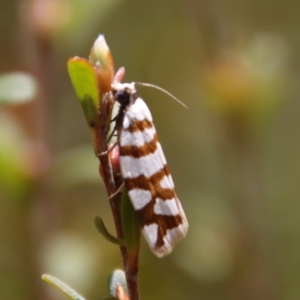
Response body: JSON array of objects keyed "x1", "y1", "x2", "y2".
[{"x1": 68, "y1": 57, "x2": 99, "y2": 128}]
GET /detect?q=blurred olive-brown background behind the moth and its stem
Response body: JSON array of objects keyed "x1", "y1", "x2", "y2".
[{"x1": 0, "y1": 0, "x2": 300, "y2": 300}]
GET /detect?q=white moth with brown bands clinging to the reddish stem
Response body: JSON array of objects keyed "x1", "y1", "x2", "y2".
[{"x1": 112, "y1": 82, "x2": 188, "y2": 257}]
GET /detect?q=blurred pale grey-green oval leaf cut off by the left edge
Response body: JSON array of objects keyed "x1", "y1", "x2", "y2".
[{"x1": 0, "y1": 72, "x2": 37, "y2": 104}]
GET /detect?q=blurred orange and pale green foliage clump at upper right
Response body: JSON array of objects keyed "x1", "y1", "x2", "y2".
[{"x1": 203, "y1": 35, "x2": 291, "y2": 130}]
